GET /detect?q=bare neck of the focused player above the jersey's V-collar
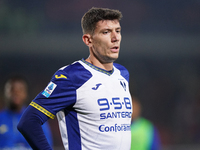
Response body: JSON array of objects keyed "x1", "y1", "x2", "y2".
[{"x1": 85, "y1": 56, "x2": 113, "y2": 71}]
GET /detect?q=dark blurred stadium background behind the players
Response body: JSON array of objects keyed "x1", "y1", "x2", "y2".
[{"x1": 0, "y1": 0, "x2": 200, "y2": 150}]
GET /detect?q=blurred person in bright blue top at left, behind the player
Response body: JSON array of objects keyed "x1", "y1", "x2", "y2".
[{"x1": 0, "y1": 76, "x2": 53, "y2": 150}]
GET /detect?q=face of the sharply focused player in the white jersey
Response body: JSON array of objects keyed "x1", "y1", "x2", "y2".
[{"x1": 91, "y1": 20, "x2": 121, "y2": 63}]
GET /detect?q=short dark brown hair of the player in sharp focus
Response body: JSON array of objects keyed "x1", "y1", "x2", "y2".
[{"x1": 81, "y1": 7, "x2": 122, "y2": 34}]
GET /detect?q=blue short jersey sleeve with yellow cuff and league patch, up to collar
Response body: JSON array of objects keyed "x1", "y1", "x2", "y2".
[{"x1": 30, "y1": 63, "x2": 91, "y2": 119}]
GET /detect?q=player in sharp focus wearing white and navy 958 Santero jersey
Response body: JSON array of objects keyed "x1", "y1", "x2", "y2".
[{"x1": 18, "y1": 7, "x2": 132, "y2": 150}]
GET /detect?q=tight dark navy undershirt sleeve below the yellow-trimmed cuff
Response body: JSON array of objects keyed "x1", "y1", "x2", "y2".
[{"x1": 17, "y1": 106, "x2": 52, "y2": 150}]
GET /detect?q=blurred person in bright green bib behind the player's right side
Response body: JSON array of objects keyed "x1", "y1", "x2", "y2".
[{"x1": 131, "y1": 97, "x2": 161, "y2": 150}]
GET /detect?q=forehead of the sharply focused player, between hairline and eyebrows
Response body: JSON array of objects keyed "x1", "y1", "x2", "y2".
[{"x1": 95, "y1": 19, "x2": 120, "y2": 30}]
